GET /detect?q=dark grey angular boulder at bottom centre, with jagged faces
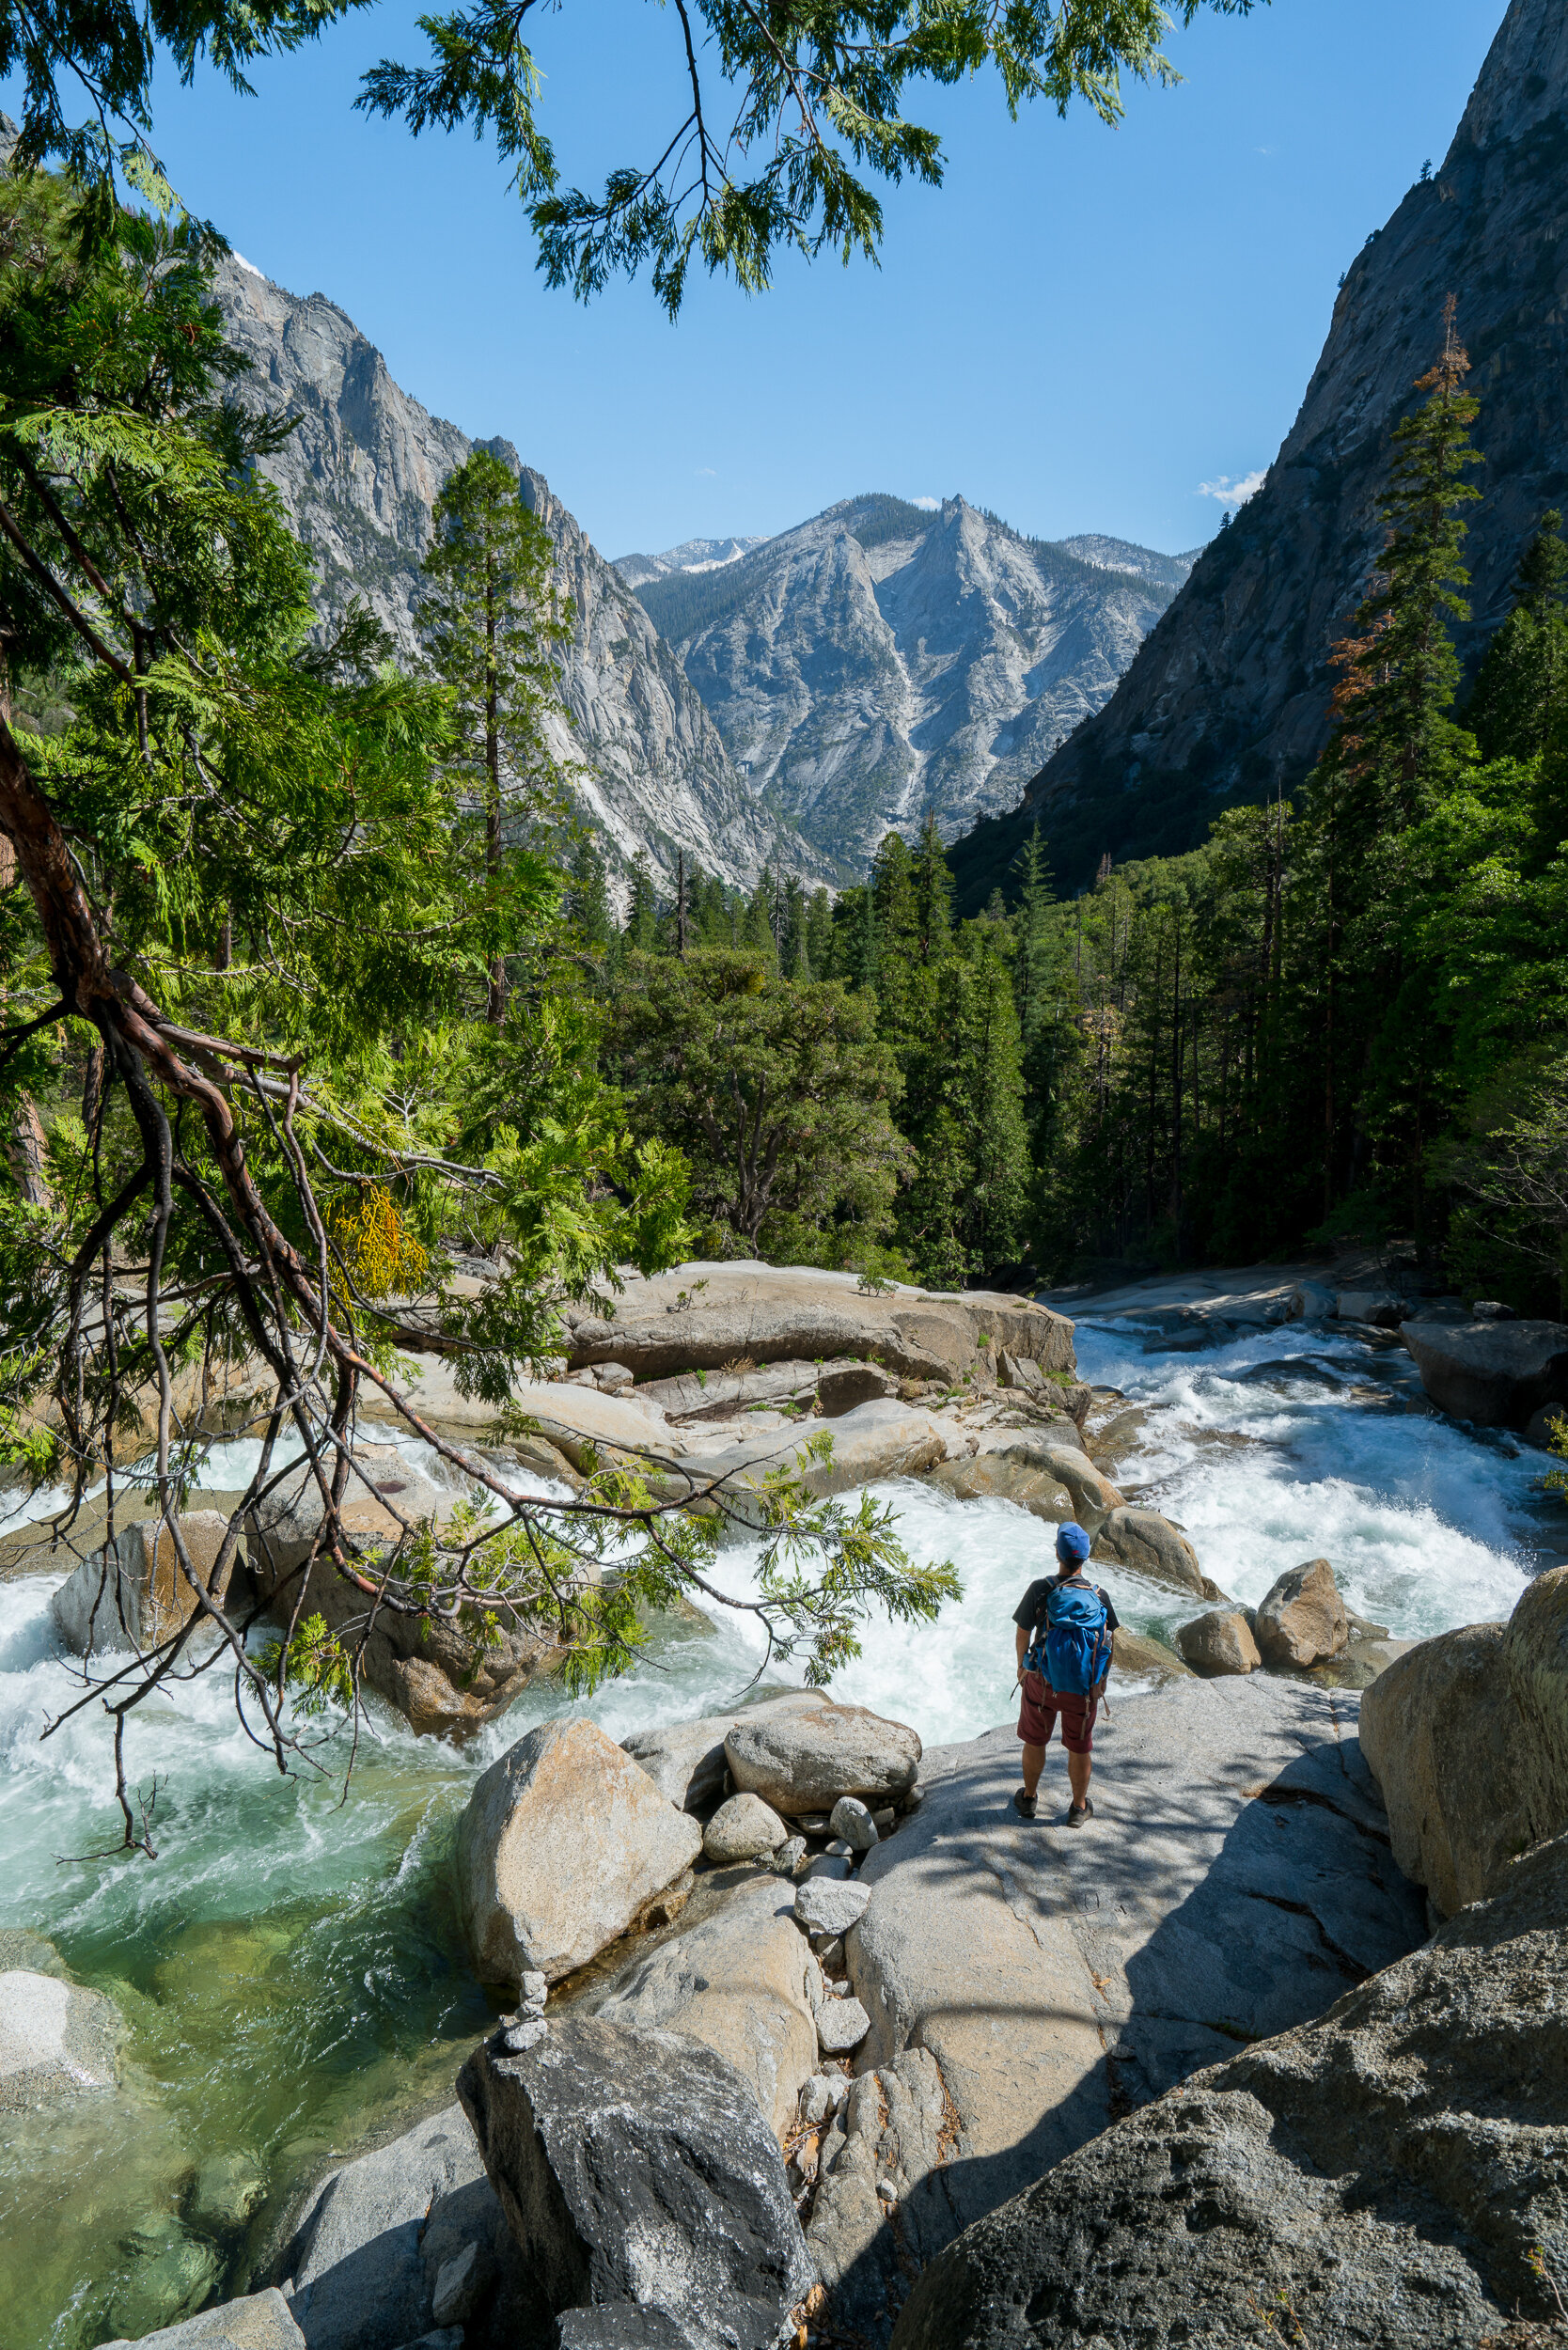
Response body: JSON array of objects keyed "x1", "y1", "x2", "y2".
[{"x1": 459, "y1": 2014, "x2": 811, "y2": 2350}]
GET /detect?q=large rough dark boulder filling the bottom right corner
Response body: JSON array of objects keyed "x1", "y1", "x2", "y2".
[{"x1": 893, "y1": 1838, "x2": 1568, "y2": 2350}]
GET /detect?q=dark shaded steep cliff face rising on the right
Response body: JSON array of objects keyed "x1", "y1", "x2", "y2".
[{"x1": 973, "y1": 0, "x2": 1568, "y2": 891}]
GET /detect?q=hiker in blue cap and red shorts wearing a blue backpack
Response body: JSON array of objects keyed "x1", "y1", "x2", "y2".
[{"x1": 1013, "y1": 1523, "x2": 1117, "y2": 1828}]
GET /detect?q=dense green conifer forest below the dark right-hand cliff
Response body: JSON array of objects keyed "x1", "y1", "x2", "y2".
[{"x1": 578, "y1": 315, "x2": 1568, "y2": 1314}]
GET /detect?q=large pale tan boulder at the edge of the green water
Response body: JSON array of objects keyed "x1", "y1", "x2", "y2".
[{"x1": 459, "y1": 1720, "x2": 703, "y2": 1983}]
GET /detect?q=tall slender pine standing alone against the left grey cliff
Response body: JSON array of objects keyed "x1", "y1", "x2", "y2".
[{"x1": 418, "y1": 449, "x2": 572, "y2": 1027}]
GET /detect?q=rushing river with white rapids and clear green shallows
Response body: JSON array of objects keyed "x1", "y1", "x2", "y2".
[{"x1": 0, "y1": 1314, "x2": 1563, "y2": 2350}]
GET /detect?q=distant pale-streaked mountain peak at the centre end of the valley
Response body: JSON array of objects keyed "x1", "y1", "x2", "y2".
[{"x1": 630, "y1": 496, "x2": 1189, "y2": 868}]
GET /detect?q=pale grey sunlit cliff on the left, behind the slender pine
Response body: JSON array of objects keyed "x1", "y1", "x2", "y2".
[{"x1": 216, "y1": 261, "x2": 827, "y2": 886}]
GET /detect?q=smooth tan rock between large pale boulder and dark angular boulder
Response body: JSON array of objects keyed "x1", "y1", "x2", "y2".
[{"x1": 595, "y1": 1880, "x2": 823, "y2": 2138}]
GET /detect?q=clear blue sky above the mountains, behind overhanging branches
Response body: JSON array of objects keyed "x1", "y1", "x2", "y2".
[{"x1": 0, "y1": 0, "x2": 1504, "y2": 555}]
